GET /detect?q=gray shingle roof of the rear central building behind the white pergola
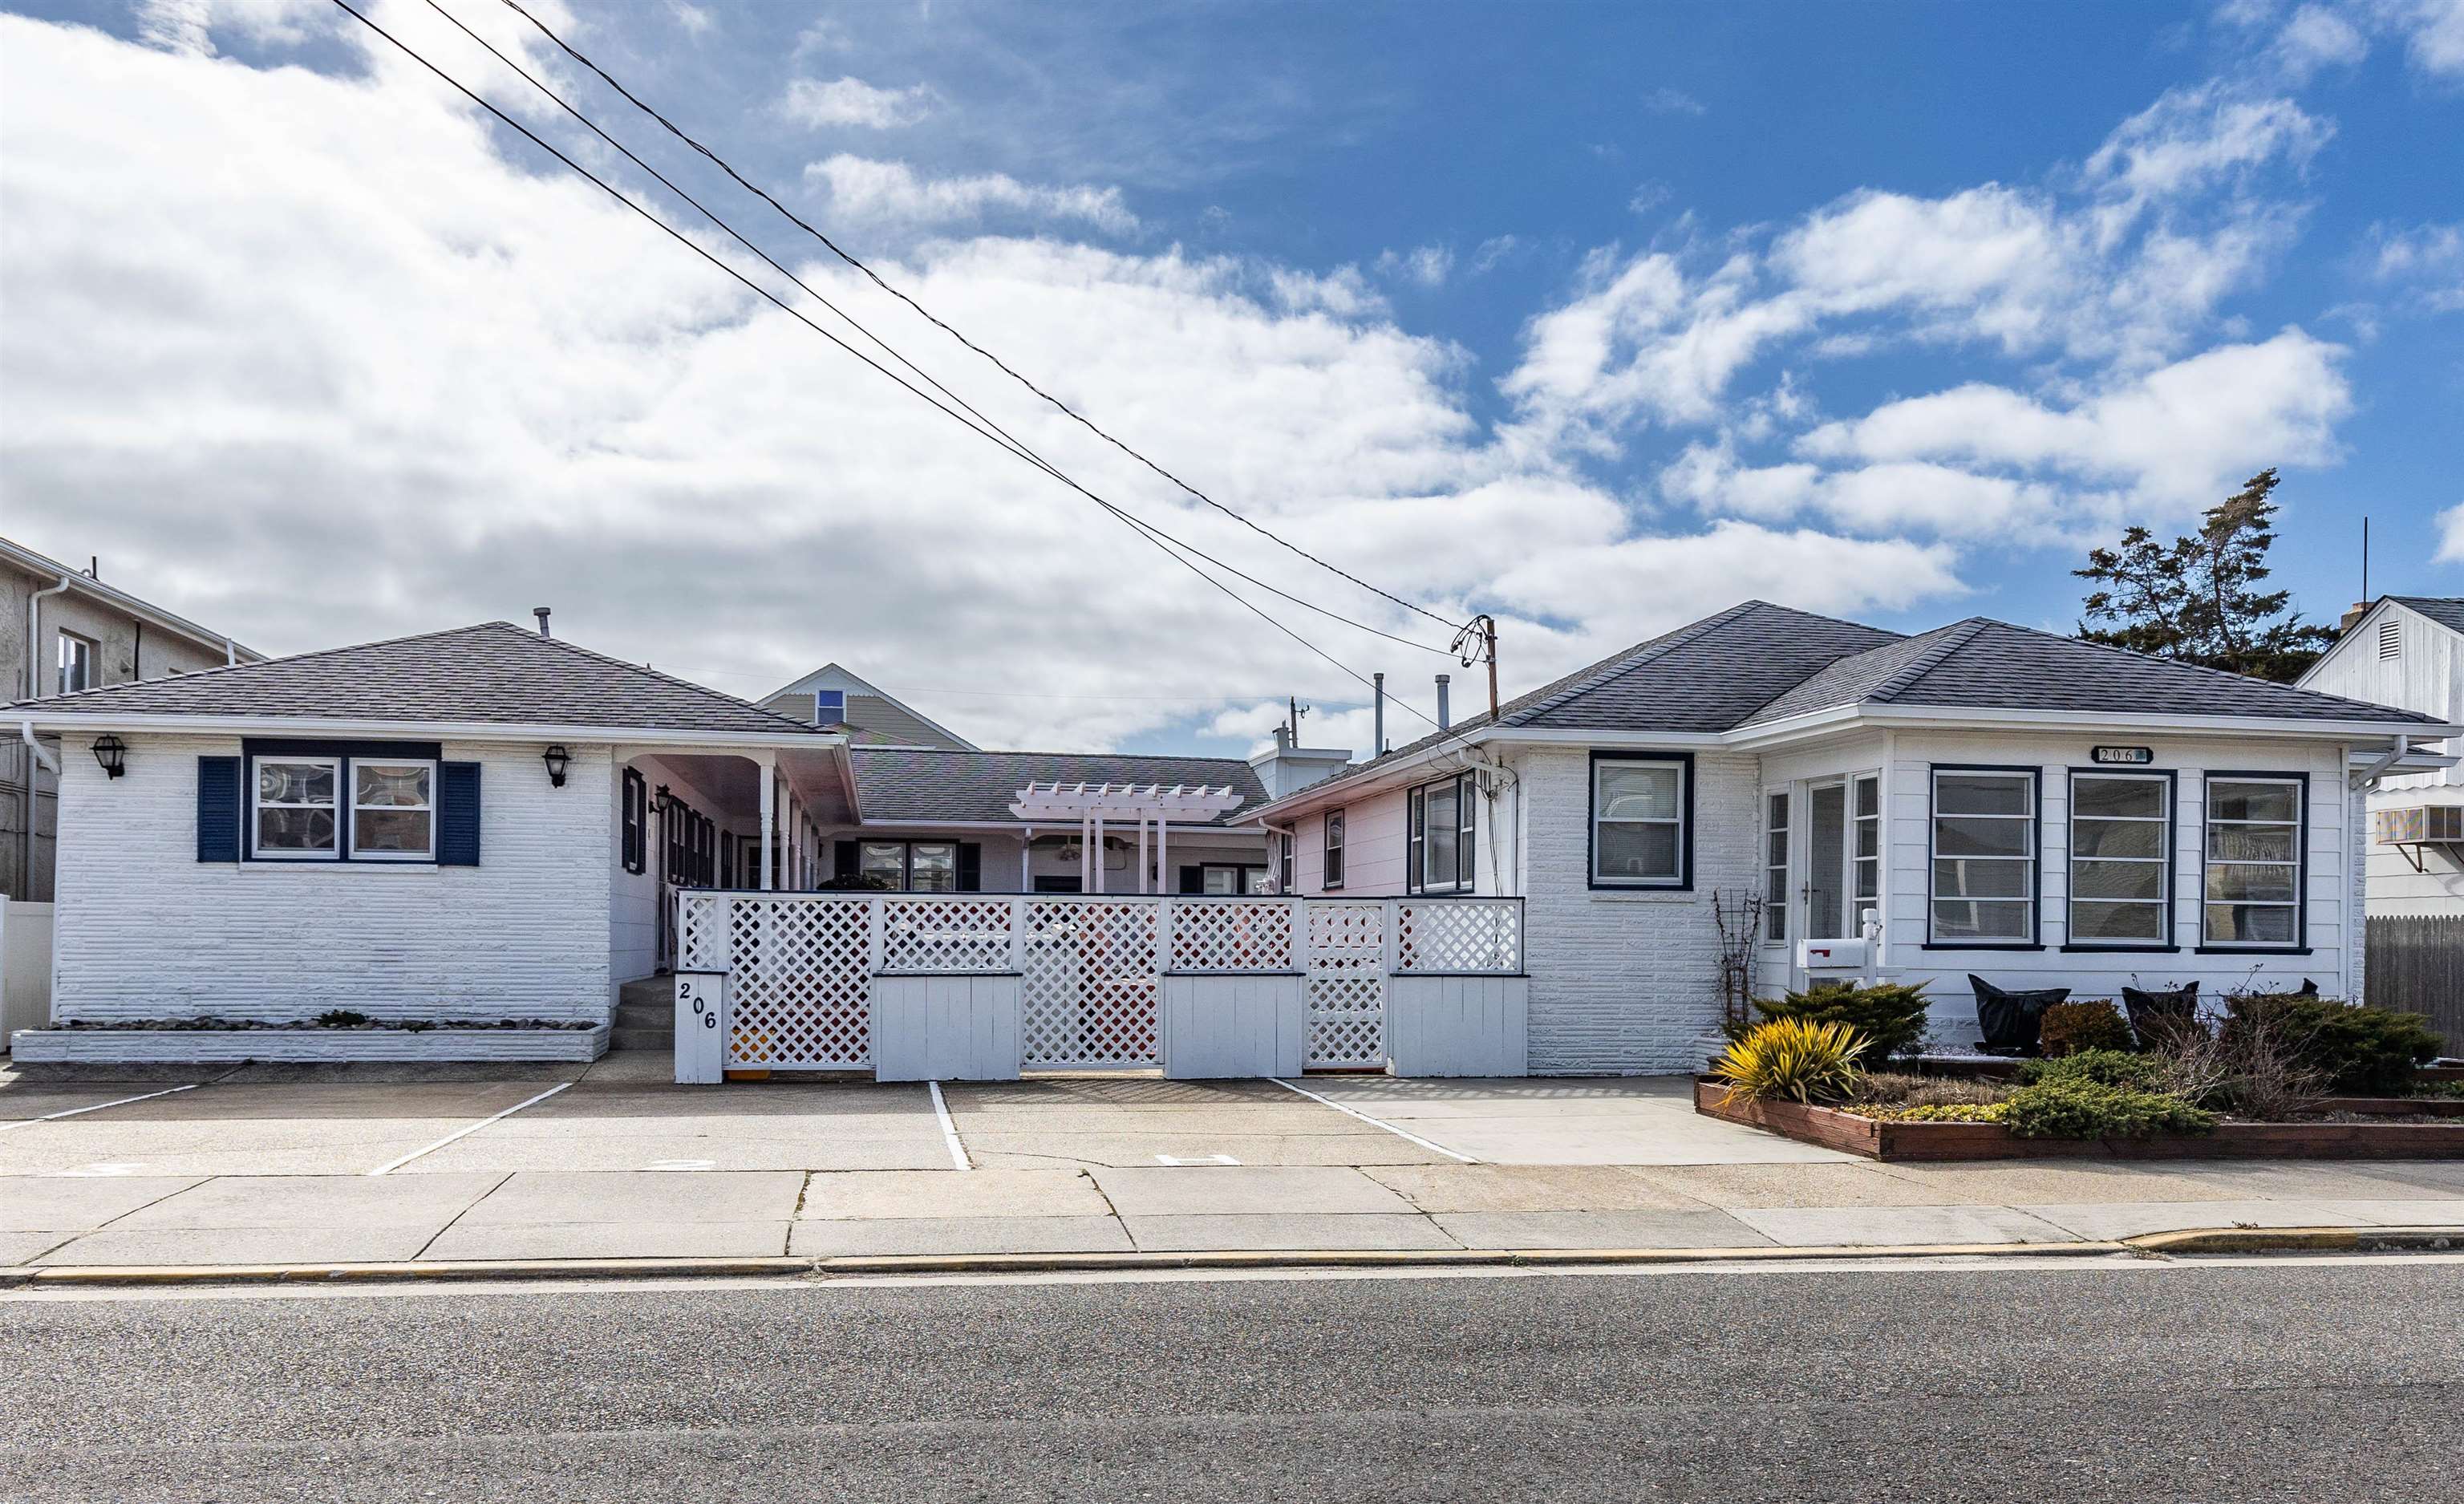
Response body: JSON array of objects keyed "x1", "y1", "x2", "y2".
[{"x1": 848, "y1": 747, "x2": 1266, "y2": 824}]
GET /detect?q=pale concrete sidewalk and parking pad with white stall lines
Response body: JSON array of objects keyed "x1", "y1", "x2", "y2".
[{"x1": 0, "y1": 1055, "x2": 2464, "y2": 1270}]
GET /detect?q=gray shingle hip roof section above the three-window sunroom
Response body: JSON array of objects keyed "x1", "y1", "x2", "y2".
[{"x1": 1742, "y1": 616, "x2": 2439, "y2": 725}]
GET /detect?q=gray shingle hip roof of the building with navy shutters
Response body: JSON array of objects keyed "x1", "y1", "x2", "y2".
[{"x1": 18, "y1": 622, "x2": 813, "y2": 735}]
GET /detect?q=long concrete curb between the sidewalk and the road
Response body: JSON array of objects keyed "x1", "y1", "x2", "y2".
[{"x1": 0, "y1": 1228, "x2": 2464, "y2": 1290}]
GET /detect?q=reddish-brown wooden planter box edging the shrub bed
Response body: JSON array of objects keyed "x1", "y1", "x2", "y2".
[{"x1": 1696, "y1": 1080, "x2": 2464, "y2": 1159}]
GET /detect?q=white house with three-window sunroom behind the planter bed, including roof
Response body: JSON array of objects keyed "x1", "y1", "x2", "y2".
[{"x1": 1252, "y1": 602, "x2": 2464, "y2": 1072}]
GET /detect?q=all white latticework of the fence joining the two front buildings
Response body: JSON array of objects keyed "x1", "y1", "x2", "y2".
[{"x1": 675, "y1": 890, "x2": 1526, "y2": 1070}]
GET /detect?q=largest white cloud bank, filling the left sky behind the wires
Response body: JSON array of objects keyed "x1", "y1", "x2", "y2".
[{"x1": 0, "y1": 14, "x2": 1959, "y2": 747}]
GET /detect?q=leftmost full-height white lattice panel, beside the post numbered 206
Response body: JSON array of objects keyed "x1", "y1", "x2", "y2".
[{"x1": 719, "y1": 898, "x2": 872, "y2": 1070}]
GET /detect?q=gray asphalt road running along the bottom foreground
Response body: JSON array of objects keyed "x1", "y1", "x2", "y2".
[{"x1": 0, "y1": 1260, "x2": 2464, "y2": 1504}]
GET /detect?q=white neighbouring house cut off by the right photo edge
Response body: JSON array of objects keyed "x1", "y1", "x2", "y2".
[{"x1": 2301, "y1": 594, "x2": 2464, "y2": 917}]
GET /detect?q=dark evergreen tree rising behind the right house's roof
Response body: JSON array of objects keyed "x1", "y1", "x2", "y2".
[{"x1": 2073, "y1": 468, "x2": 2336, "y2": 683}]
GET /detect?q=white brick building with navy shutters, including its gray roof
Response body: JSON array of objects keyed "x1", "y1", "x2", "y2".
[{"x1": 12, "y1": 619, "x2": 853, "y2": 1060}]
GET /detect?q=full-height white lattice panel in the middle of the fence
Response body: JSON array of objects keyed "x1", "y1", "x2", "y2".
[{"x1": 1018, "y1": 898, "x2": 1161, "y2": 1070}]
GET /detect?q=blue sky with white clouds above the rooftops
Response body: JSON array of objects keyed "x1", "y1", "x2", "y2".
[{"x1": 0, "y1": 0, "x2": 2464, "y2": 752}]
